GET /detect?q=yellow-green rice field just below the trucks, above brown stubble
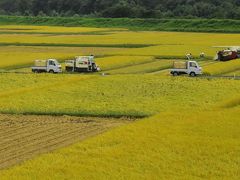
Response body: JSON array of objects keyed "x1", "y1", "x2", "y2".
[{"x1": 0, "y1": 74, "x2": 240, "y2": 117}]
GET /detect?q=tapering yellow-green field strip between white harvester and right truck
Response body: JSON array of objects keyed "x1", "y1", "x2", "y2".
[{"x1": 107, "y1": 60, "x2": 173, "y2": 74}]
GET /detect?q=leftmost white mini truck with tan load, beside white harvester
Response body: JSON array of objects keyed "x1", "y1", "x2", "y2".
[{"x1": 32, "y1": 59, "x2": 62, "y2": 73}]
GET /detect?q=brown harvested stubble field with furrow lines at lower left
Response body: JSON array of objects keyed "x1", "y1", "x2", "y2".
[{"x1": 0, "y1": 115, "x2": 130, "y2": 169}]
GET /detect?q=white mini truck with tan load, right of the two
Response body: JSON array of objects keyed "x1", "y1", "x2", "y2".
[{"x1": 170, "y1": 61, "x2": 202, "y2": 77}]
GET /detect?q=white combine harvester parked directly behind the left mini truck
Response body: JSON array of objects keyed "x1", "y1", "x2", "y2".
[{"x1": 65, "y1": 56, "x2": 100, "y2": 72}]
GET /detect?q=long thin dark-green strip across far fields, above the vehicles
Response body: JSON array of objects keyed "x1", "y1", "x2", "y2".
[{"x1": 0, "y1": 42, "x2": 154, "y2": 48}]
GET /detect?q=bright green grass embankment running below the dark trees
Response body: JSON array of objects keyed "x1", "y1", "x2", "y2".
[{"x1": 0, "y1": 16, "x2": 240, "y2": 33}]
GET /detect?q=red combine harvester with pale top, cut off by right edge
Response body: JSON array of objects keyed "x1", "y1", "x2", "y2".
[{"x1": 215, "y1": 46, "x2": 240, "y2": 61}]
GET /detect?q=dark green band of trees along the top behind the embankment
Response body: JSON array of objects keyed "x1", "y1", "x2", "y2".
[{"x1": 0, "y1": 0, "x2": 240, "y2": 19}]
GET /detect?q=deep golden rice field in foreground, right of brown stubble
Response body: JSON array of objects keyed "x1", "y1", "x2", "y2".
[{"x1": 0, "y1": 110, "x2": 240, "y2": 179}]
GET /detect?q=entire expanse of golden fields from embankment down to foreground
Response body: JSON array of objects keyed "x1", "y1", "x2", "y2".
[{"x1": 0, "y1": 25, "x2": 240, "y2": 180}]
